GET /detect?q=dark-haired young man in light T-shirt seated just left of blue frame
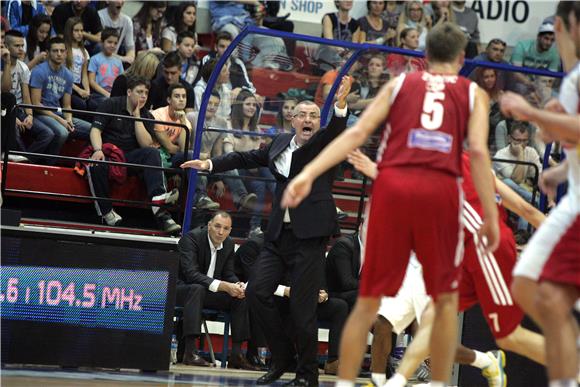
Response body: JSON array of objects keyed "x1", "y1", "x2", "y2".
[{"x1": 151, "y1": 83, "x2": 191, "y2": 168}]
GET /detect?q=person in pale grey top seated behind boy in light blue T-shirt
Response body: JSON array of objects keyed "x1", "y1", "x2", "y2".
[{"x1": 98, "y1": 0, "x2": 135, "y2": 65}]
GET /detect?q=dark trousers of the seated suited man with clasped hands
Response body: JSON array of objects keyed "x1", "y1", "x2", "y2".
[{"x1": 176, "y1": 284, "x2": 250, "y2": 343}]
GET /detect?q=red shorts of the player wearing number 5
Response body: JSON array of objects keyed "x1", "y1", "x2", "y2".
[{"x1": 359, "y1": 168, "x2": 463, "y2": 298}]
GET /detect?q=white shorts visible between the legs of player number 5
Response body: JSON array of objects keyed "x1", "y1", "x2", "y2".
[{"x1": 377, "y1": 254, "x2": 431, "y2": 334}]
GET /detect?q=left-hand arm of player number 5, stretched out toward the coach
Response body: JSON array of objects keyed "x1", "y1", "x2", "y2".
[{"x1": 281, "y1": 77, "x2": 399, "y2": 207}]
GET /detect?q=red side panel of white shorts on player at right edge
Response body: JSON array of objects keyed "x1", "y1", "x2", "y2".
[{"x1": 540, "y1": 215, "x2": 580, "y2": 289}]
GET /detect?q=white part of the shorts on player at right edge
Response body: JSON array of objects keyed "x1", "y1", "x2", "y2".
[{"x1": 513, "y1": 195, "x2": 578, "y2": 281}]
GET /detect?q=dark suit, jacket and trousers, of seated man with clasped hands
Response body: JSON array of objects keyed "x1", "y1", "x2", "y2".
[{"x1": 176, "y1": 226, "x2": 249, "y2": 342}]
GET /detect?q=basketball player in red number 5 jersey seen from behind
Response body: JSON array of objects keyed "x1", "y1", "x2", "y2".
[{"x1": 282, "y1": 23, "x2": 499, "y2": 387}]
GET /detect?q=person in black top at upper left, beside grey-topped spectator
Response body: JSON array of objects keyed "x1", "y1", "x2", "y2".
[{"x1": 51, "y1": 0, "x2": 103, "y2": 55}]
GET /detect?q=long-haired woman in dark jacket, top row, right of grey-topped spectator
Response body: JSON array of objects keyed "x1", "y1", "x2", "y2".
[{"x1": 133, "y1": 1, "x2": 167, "y2": 54}]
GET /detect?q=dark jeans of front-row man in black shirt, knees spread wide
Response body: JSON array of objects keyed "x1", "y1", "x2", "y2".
[{"x1": 88, "y1": 148, "x2": 166, "y2": 216}]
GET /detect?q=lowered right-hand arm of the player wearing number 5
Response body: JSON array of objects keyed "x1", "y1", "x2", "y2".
[{"x1": 467, "y1": 87, "x2": 499, "y2": 251}]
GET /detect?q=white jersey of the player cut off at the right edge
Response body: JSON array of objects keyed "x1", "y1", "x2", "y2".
[{"x1": 558, "y1": 62, "x2": 580, "y2": 213}]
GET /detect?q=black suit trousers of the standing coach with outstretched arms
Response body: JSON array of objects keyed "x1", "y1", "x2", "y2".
[{"x1": 246, "y1": 229, "x2": 327, "y2": 381}]
